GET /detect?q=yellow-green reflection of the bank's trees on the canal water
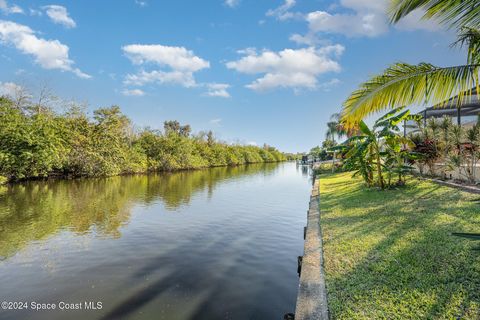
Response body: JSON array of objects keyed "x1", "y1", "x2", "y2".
[{"x1": 0, "y1": 163, "x2": 277, "y2": 259}]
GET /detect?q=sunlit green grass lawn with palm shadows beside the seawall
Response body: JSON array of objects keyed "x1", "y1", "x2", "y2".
[{"x1": 320, "y1": 173, "x2": 480, "y2": 319}]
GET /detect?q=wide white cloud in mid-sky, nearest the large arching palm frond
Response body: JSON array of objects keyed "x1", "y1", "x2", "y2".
[{"x1": 226, "y1": 44, "x2": 345, "y2": 91}]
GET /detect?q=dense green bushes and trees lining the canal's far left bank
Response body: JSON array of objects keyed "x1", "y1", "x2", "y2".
[{"x1": 0, "y1": 97, "x2": 286, "y2": 181}]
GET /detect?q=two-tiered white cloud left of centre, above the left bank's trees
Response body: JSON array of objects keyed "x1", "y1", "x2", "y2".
[{"x1": 122, "y1": 44, "x2": 210, "y2": 87}]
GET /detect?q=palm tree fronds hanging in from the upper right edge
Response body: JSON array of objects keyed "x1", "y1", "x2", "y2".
[{"x1": 342, "y1": 0, "x2": 480, "y2": 127}]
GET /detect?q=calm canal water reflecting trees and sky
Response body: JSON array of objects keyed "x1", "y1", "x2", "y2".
[{"x1": 0, "y1": 163, "x2": 311, "y2": 320}]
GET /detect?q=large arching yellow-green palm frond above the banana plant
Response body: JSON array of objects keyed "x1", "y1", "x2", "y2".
[{"x1": 342, "y1": 63, "x2": 480, "y2": 127}]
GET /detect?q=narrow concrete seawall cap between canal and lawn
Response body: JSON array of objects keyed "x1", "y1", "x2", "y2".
[{"x1": 295, "y1": 179, "x2": 328, "y2": 320}]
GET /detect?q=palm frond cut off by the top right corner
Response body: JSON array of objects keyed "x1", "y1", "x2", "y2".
[{"x1": 388, "y1": 0, "x2": 480, "y2": 28}]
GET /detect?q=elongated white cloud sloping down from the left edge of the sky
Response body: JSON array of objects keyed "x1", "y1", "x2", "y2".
[{"x1": 0, "y1": 20, "x2": 91, "y2": 79}]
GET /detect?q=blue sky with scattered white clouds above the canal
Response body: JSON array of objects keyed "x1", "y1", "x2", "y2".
[{"x1": 0, "y1": 0, "x2": 465, "y2": 152}]
